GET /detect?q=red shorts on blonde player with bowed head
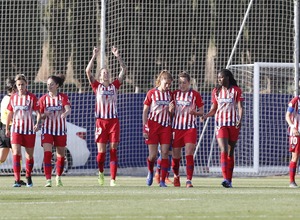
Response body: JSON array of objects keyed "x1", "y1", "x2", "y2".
[{"x1": 145, "y1": 120, "x2": 172, "y2": 145}]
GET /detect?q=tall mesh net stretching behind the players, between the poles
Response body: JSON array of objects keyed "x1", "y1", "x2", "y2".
[{"x1": 0, "y1": 0, "x2": 294, "y2": 175}]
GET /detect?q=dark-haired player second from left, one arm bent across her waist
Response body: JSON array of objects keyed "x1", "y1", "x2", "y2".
[{"x1": 39, "y1": 75, "x2": 71, "y2": 187}]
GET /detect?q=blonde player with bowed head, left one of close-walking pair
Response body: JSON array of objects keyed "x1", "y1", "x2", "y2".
[{"x1": 143, "y1": 70, "x2": 174, "y2": 187}]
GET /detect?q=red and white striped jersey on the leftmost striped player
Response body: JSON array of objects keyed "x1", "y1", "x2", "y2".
[{"x1": 7, "y1": 92, "x2": 39, "y2": 134}]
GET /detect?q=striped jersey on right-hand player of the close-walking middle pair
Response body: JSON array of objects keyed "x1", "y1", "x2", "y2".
[{"x1": 172, "y1": 89, "x2": 204, "y2": 130}]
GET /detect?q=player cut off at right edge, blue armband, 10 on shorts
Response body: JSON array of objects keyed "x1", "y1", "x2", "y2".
[{"x1": 285, "y1": 96, "x2": 300, "y2": 188}]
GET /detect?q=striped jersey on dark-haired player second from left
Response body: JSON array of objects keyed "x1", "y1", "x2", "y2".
[{"x1": 39, "y1": 93, "x2": 71, "y2": 135}]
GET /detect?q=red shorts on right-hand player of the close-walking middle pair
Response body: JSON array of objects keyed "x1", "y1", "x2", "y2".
[{"x1": 172, "y1": 128, "x2": 197, "y2": 148}]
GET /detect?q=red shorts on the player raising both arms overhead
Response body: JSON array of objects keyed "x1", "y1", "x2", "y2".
[{"x1": 95, "y1": 118, "x2": 120, "y2": 143}]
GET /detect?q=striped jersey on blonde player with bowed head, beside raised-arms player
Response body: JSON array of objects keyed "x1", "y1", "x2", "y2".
[{"x1": 144, "y1": 88, "x2": 172, "y2": 127}]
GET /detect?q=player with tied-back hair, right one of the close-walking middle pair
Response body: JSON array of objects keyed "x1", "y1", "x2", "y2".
[{"x1": 172, "y1": 72, "x2": 204, "y2": 188}]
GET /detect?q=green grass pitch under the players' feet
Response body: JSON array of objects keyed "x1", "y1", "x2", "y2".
[{"x1": 0, "y1": 176, "x2": 300, "y2": 220}]
